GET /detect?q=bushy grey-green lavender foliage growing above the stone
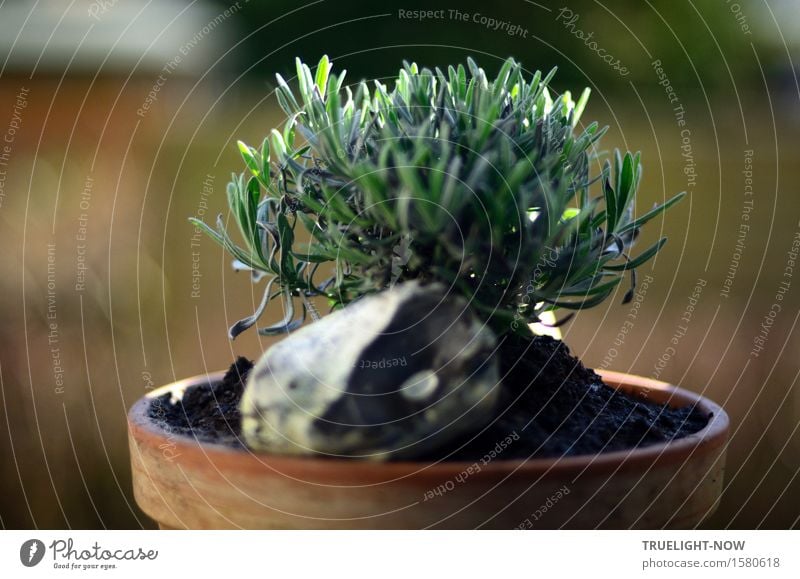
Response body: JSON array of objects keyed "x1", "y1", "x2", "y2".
[{"x1": 192, "y1": 57, "x2": 683, "y2": 338}]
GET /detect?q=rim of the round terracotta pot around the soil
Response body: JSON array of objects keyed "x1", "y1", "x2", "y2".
[{"x1": 128, "y1": 370, "x2": 729, "y2": 486}]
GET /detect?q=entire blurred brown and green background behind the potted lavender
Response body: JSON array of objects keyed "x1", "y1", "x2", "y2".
[{"x1": 0, "y1": 0, "x2": 800, "y2": 528}]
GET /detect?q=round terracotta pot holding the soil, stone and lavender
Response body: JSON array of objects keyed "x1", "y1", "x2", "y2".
[{"x1": 128, "y1": 372, "x2": 728, "y2": 529}]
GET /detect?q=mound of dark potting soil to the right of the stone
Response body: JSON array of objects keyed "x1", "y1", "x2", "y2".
[{"x1": 440, "y1": 336, "x2": 711, "y2": 460}]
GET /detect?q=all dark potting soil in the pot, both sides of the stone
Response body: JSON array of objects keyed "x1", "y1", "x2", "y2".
[{"x1": 149, "y1": 336, "x2": 711, "y2": 461}]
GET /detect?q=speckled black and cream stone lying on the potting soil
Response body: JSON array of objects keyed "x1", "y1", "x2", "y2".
[{"x1": 241, "y1": 282, "x2": 499, "y2": 460}]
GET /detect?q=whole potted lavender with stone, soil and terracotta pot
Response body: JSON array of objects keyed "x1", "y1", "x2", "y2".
[{"x1": 129, "y1": 57, "x2": 728, "y2": 528}]
